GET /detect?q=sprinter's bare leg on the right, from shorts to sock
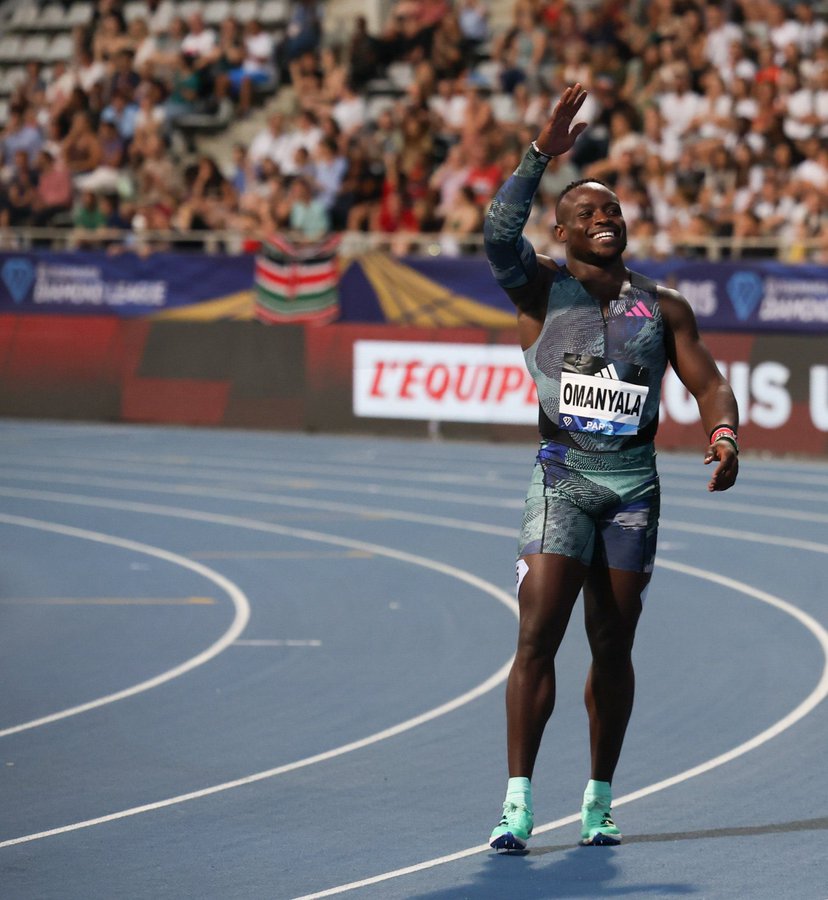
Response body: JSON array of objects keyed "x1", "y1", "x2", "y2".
[{"x1": 584, "y1": 566, "x2": 650, "y2": 782}]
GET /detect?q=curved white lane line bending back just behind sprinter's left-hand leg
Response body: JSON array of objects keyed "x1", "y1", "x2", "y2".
[{"x1": 0, "y1": 488, "x2": 517, "y2": 849}]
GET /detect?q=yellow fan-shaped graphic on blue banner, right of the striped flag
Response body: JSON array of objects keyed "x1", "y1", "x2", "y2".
[{"x1": 358, "y1": 251, "x2": 515, "y2": 328}]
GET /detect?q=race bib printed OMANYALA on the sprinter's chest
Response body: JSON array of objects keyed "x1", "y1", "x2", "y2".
[{"x1": 558, "y1": 353, "x2": 650, "y2": 435}]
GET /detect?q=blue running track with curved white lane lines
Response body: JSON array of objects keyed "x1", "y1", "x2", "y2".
[{"x1": 0, "y1": 422, "x2": 828, "y2": 900}]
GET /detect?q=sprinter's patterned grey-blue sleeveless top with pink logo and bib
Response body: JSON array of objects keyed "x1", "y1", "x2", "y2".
[{"x1": 523, "y1": 268, "x2": 667, "y2": 451}]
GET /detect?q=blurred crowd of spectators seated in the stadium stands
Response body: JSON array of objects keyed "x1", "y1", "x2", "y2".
[{"x1": 0, "y1": 0, "x2": 828, "y2": 262}]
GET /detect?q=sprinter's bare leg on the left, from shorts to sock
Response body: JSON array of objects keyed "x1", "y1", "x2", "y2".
[{"x1": 506, "y1": 553, "x2": 586, "y2": 778}]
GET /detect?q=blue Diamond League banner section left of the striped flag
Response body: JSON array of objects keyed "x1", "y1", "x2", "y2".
[{"x1": 0, "y1": 252, "x2": 254, "y2": 317}]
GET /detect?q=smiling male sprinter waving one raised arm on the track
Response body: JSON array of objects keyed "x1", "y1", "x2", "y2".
[{"x1": 484, "y1": 84, "x2": 739, "y2": 850}]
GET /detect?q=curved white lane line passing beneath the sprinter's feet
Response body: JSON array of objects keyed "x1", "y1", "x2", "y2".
[{"x1": 295, "y1": 560, "x2": 828, "y2": 900}]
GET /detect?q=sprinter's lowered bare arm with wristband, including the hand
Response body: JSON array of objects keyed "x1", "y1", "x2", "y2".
[{"x1": 658, "y1": 287, "x2": 739, "y2": 491}]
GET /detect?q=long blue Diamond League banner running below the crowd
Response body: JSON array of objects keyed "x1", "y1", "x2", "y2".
[{"x1": 0, "y1": 251, "x2": 828, "y2": 334}]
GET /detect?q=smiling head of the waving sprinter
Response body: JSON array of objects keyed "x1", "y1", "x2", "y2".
[{"x1": 555, "y1": 182, "x2": 627, "y2": 266}]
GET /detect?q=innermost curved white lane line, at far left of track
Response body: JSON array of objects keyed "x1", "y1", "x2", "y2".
[{"x1": 0, "y1": 514, "x2": 250, "y2": 738}]
